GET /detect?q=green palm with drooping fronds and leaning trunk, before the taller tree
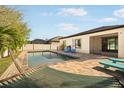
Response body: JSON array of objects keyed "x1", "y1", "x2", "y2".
[{"x1": 0, "y1": 27, "x2": 22, "y2": 73}]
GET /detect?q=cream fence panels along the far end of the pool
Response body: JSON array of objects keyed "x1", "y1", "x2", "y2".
[{"x1": 22, "y1": 44, "x2": 59, "y2": 51}]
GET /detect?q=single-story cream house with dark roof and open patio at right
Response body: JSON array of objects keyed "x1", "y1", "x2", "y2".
[{"x1": 60, "y1": 25, "x2": 124, "y2": 58}]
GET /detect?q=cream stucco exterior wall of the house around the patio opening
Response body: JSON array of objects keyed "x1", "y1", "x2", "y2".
[{"x1": 60, "y1": 28, "x2": 124, "y2": 57}]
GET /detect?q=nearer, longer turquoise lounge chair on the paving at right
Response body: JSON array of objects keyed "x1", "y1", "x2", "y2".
[{"x1": 99, "y1": 60, "x2": 124, "y2": 71}]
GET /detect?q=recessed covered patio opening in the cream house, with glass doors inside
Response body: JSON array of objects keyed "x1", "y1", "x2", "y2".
[{"x1": 90, "y1": 33, "x2": 118, "y2": 57}]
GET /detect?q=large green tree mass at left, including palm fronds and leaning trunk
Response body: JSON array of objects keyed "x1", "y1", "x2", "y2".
[{"x1": 0, "y1": 6, "x2": 30, "y2": 73}]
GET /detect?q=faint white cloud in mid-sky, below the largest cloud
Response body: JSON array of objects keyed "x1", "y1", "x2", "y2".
[{"x1": 58, "y1": 23, "x2": 79, "y2": 31}]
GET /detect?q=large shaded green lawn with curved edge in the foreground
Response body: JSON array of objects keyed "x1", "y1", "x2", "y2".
[{"x1": 3, "y1": 67, "x2": 120, "y2": 88}]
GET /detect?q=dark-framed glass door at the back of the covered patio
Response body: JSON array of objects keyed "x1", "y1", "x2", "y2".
[{"x1": 102, "y1": 37, "x2": 118, "y2": 52}]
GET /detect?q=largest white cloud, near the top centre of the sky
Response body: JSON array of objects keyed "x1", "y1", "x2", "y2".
[{"x1": 57, "y1": 8, "x2": 87, "y2": 16}]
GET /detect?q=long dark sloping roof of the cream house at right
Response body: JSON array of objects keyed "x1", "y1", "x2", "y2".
[{"x1": 62, "y1": 25, "x2": 124, "y2": 39}]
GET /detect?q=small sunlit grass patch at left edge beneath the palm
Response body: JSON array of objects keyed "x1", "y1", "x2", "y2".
[{"x1": 0, "y1": 57, "x2": 12, "y2": 76}]
